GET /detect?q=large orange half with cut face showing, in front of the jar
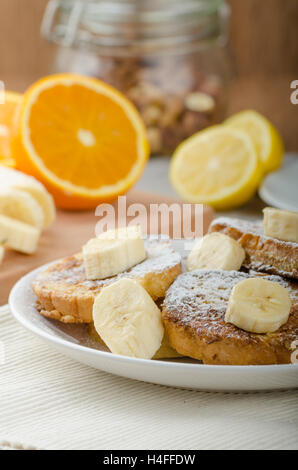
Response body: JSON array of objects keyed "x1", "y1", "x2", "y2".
[{"x1": 15, "y1": 74, "x2": 149, "y2": 209}]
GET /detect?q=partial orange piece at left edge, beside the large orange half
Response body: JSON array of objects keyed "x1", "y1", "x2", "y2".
[{"x1": 0, "y1": 91, "x2": 23, "y2": 167}]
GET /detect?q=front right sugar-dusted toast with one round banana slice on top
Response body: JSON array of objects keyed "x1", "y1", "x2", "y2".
[{"x1": 162, "y1": 270, "x2": 298, "y2": 365}]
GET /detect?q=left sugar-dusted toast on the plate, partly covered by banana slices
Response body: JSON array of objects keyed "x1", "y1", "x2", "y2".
[{"x1": 33, "y1": 241, "x2": 182, "y2": 323}]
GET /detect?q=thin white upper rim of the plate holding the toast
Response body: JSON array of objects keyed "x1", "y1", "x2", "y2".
[{"x1": 8, "y1": 258, "x2": 298, "y2": 374}]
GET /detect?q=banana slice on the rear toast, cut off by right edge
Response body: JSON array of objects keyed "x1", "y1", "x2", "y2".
[{"x1": 263, "y1": 207, "x2": 298, "y2": 243}]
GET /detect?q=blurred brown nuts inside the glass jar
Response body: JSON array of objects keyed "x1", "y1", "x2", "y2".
[{"x1": 97, "y1": 55, "x2": 224, "y2": 154}]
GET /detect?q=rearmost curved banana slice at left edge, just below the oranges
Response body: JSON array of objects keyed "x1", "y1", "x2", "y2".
[{"x1": 0, "y1": 167, "x2": 56, "y2": 228}]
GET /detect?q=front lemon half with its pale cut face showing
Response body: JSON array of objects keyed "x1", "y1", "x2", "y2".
[{"x1": 169, "y1": 126, "x2": 262, "y2": 210}]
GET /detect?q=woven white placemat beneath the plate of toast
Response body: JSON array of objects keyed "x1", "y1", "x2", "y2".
[{"x1": 0, "y1": 307, "x2": 298, "y2": 450}]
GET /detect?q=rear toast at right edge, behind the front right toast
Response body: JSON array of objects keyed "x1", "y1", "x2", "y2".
[{"x1": 209, "y1": 217, "x2": 298, "y2": 279}]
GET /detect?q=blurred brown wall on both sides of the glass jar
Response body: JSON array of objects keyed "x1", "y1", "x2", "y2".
[{"x1": 0, "y1": 0, "x2": 298, "y2": 151}]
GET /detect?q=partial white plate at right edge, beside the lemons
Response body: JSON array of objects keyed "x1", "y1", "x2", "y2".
[{"x1": 259, "y1": 153, "x2": 298, "y2": 212}]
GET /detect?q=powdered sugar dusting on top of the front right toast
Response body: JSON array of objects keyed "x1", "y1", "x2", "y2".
[{"x1": 163, "y1": 270, "x2": 298, "y2": 341}]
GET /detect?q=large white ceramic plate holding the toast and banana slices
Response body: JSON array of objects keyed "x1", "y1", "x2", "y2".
[{"x1": 9, "y1": 241, "x2": 298, "y2": 392}]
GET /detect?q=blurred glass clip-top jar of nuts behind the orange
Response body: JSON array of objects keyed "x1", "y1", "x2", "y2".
[{"x1": 42, "y1": 0, "x2": 230, "y2": 154}]
